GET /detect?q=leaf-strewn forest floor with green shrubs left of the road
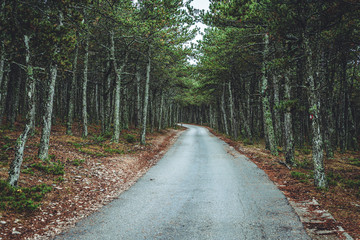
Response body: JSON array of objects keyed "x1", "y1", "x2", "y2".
[{"x1": 0, "y1": 125, "x2": 182, "y2": 240}]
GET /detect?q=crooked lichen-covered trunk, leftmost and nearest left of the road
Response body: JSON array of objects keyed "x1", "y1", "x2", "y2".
[{"x1": 8, "y1": 35, "x2": 35, "y2": 186}]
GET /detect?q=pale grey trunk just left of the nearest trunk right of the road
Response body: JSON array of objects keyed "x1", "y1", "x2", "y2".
[{"x1": 284, "y1": 70, "x2": 295, "y2": 166}]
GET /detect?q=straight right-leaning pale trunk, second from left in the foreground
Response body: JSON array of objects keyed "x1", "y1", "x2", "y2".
[{"x1": 38, "y1": 63, "x2": 57, "y2": 160}]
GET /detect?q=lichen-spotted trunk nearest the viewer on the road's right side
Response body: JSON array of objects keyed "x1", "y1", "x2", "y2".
[{"x1": 303, "y1": 35, "x2": 327, "y2": 187}]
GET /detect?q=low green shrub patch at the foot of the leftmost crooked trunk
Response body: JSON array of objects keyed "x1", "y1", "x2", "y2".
[{"x1": 0, "y1": 180, "x2": 52, "y2": 212}]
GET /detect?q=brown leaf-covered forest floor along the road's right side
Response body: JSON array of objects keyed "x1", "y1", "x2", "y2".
[{"x1": 209, "y1": 128, "x2": 360, "y2": 239}]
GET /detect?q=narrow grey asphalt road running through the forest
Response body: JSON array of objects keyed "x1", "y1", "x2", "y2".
[{"x1": 56, "y1": 125, "x2": 310, "y2": 240}]
